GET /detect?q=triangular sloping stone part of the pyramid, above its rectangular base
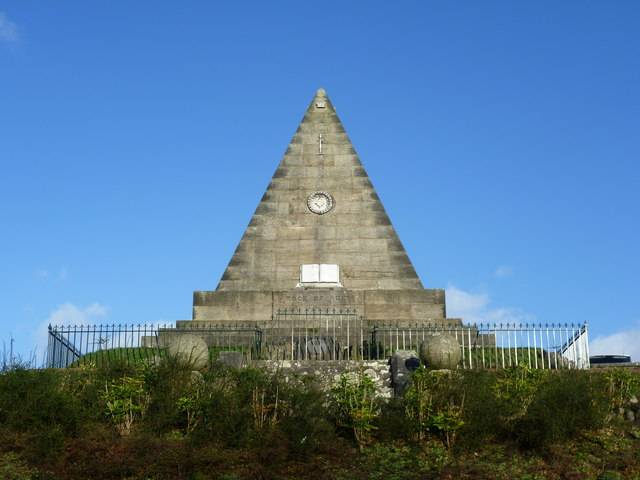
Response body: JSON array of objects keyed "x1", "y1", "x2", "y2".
[{"x1": 217, "y1": 89, "x2": 423, "y2": 292}]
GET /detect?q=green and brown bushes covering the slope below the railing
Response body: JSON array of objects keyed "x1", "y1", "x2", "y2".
[{"x1": 0, "y1": 358, "x2": 640, "y2": 480}]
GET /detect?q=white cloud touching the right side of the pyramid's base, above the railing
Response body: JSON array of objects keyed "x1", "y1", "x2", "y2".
[{"x1": 446, "y1": 285, "x2": 535, "y2": 324}]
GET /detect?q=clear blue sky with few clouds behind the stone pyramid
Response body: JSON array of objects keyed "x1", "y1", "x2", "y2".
[{"x1": 0, "y1": 0, "x2": 640, "y2": 357}]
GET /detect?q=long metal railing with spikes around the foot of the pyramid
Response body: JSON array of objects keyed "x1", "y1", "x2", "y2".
[{"x1": 46, "y1": 316, "x2": 589, "y2": 369}]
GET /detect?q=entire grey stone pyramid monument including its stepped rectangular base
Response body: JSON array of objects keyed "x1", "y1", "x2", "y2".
[{"x1": 189, "y1": 89, "x2": 450, "y2": 331}]
